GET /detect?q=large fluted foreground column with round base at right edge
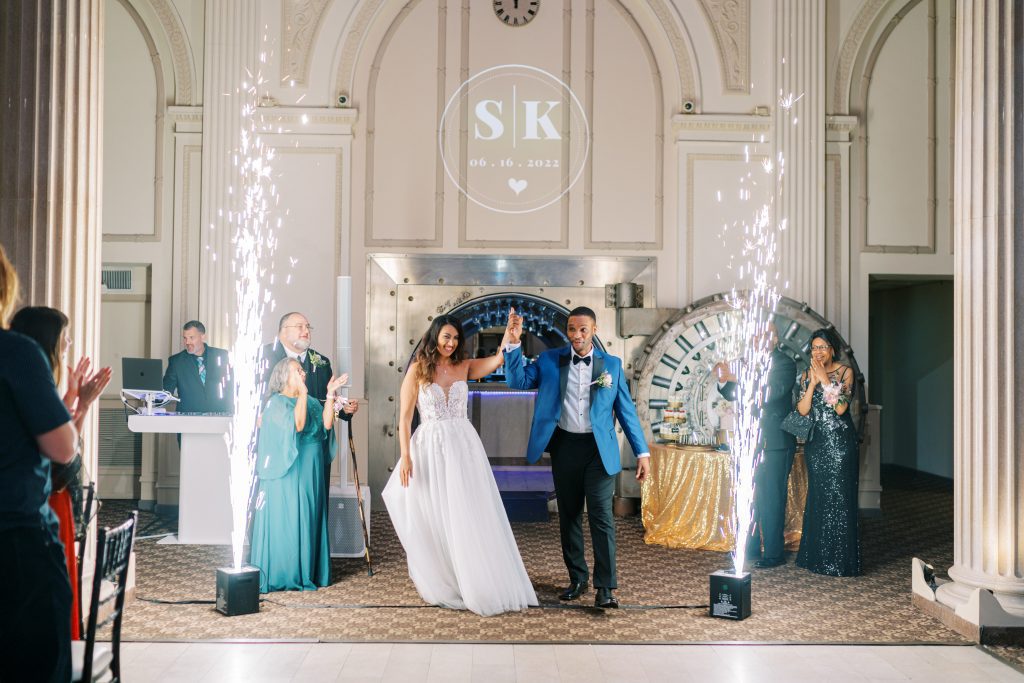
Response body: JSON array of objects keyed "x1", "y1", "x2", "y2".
[{"x1": 936, "y1": 0, "x2": 1024, "y2": 626}]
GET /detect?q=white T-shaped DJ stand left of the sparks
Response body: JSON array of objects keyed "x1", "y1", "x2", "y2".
[{"x1": 128, "y1": 414, "x2": 231, "y2": 546}]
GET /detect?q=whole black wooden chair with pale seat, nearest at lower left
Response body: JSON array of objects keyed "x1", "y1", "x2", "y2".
[{"x1": 72, "y1": 511, "x2": 138, "y2": 682}]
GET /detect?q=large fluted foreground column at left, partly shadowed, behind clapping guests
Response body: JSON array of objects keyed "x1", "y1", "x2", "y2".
[{"x1": 0, "y1": 0, "x2": 103, "y2": 574}]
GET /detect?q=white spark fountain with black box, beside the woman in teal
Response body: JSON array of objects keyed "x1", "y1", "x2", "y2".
[{"x1": 217, "y1": 45, "x2": 280, "y2": 616}]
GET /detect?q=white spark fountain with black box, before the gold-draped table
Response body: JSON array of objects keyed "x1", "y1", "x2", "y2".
[{"x1": 710, "y1": 90, "x2": 800, "y2": 620}]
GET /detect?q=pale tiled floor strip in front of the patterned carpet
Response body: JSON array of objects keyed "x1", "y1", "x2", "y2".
[{"x1": 122, "y1": 643, "x2": 1024, "y2": 683}]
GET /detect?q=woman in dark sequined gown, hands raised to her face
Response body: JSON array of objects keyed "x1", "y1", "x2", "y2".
[{"x1": 797, "y1": 330, "x2": 860, "y2": 577}]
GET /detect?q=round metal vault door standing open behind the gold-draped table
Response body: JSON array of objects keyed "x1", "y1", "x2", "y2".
[{"x1": 634, "y1": 295, "x2": 866, "y2": 442}]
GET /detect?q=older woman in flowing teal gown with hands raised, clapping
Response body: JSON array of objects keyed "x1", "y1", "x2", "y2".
[{"x1": 250, "y1": 358, "x2": 346, "y2": 593}]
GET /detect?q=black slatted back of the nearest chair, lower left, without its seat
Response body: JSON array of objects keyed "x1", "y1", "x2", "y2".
[{"x1": 82, "y1": 510, "x2": 138, "y2": 681}]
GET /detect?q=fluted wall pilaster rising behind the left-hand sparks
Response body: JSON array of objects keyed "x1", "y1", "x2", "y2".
[{"x1": 200, "y1": 0, "x2": 260, "y2": 346}]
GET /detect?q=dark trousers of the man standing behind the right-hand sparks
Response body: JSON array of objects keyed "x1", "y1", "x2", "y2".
[{"x1": 748, "y1": 449, "x2": 796, "y2": 560}]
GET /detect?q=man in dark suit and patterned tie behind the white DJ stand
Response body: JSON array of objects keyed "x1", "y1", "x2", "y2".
[{"x1": 164, "y1": 321, "x2": 234, "y2": 413}]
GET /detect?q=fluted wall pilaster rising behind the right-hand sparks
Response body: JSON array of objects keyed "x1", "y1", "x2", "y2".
[{"x1": 774, "y1": 0, "x2": 825, "y2": 313}]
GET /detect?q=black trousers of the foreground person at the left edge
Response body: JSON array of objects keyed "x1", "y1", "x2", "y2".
[{"x1": 0, "y1": 527, "x2": 71, "y2": 683}]
